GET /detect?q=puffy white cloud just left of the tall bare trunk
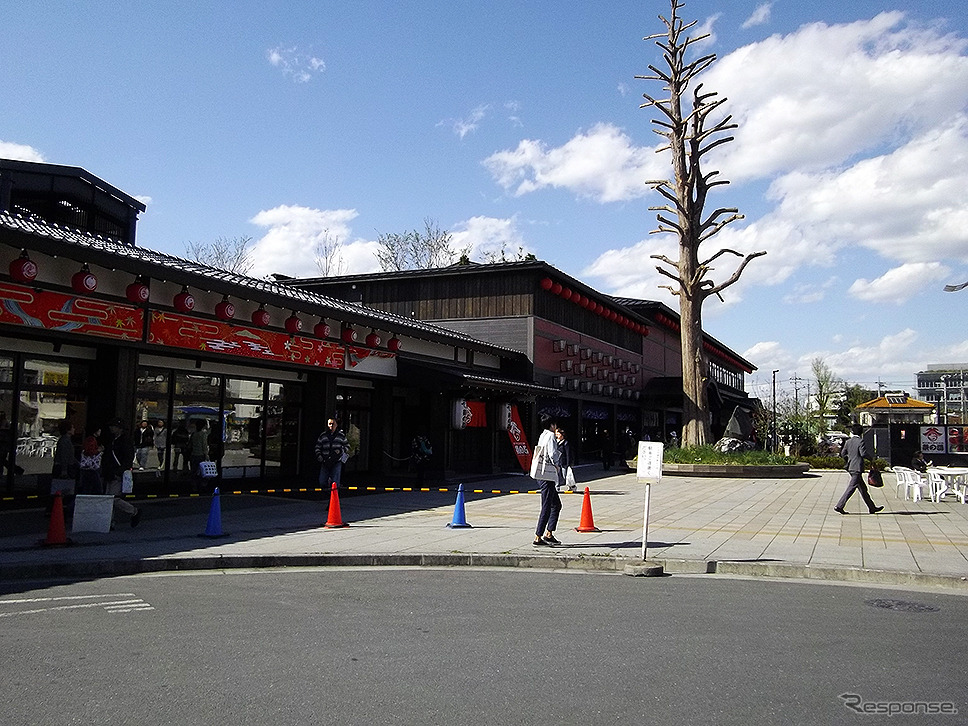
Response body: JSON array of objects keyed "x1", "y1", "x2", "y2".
[{"x1": 484, "y1": 123, "x2": 669, "y2": 202}]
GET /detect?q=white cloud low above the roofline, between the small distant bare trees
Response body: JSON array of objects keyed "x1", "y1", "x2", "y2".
[{"x1": 249, "y1": 205, "x2": 379, "y2": 277}]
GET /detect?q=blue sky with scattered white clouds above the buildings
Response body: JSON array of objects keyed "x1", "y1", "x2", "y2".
[{"x1": 0, "y1": 0, "x2": 968, "y2": 404}]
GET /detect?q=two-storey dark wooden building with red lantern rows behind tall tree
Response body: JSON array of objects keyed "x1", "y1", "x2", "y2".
[{"x1": 285, "y1": 260, "x2": 758, "y2": 458}]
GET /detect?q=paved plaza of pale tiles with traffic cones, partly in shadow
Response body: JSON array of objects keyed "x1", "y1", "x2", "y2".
[{"x1": 0, "y1": 465, "x2": 968, "y2": 588}]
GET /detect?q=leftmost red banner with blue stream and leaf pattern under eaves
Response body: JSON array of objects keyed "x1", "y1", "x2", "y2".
[{"x1": 0, "y1": 282, "x2": 144, "y2": 340}]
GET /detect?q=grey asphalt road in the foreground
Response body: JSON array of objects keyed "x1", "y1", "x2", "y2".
[{"x1": 0, "y1": 568, "x2": 968, "y2": 726}]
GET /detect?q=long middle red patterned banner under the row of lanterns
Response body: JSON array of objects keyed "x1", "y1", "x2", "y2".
[{"x1": 148, "y1": 312, "x2": 346, "y2": 370}]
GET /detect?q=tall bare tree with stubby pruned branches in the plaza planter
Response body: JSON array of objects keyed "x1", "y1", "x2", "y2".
[{"x1": 636, "y1": 0, "x2": 766, "y2": 446}]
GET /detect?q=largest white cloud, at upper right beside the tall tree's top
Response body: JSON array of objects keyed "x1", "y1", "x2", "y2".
[{"x1": 703, "y1": 12, "x2": 968, "y2": 182}]
